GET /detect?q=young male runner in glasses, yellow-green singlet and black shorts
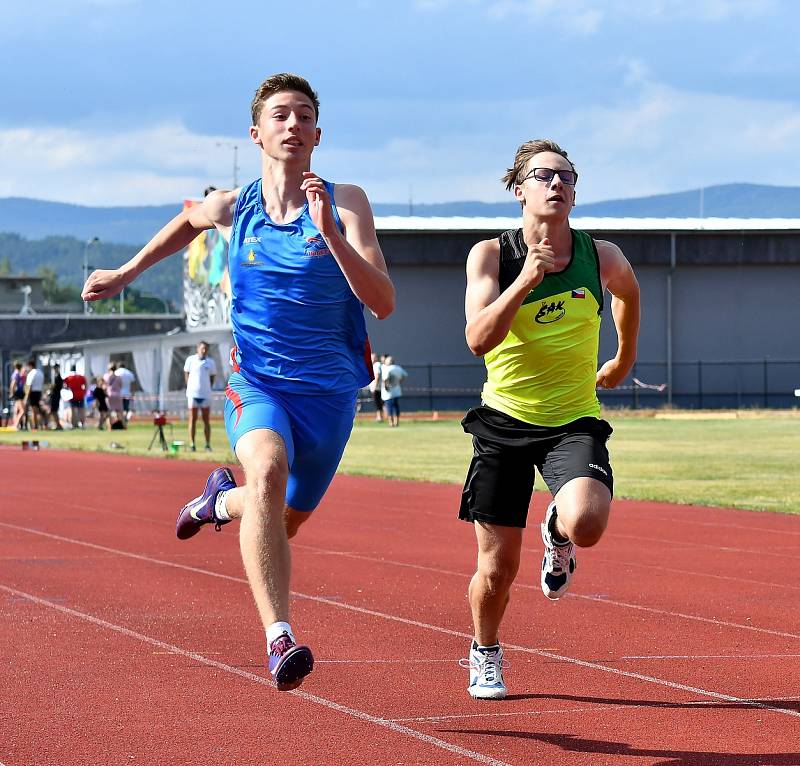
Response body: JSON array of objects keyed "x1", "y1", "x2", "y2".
[{"x1": 459, "y1": 140, "x2": 639, "y2": 699}]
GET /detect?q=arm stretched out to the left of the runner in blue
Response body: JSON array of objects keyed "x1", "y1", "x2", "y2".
[{"x1": 81, "y1": 190, "x2": 237, "y2": 301}]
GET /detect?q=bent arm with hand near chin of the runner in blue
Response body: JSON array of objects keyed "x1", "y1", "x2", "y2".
[{"x1": 301, "y1": 172, "x2": 395, "y2": 319}]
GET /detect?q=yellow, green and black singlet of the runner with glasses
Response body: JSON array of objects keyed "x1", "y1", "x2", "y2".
[{"x1": 482, "y1": 229, "x2": 603, "y2": 426}]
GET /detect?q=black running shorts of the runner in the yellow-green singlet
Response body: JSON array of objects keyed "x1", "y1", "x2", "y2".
[{"x1": 458, "y1": 405, "x2": 614, "y2": 527}]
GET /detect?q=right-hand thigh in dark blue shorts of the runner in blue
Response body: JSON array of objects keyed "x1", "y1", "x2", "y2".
[{"x1": 286, "y1": 391, "x2": 358, "y2": 512}]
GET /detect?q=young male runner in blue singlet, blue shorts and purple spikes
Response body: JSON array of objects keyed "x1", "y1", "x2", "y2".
[{"x1": 83, "y1": 74, "x2": 394, "y2": 690}]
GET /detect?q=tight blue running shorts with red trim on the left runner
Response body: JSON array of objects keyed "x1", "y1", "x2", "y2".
[{"x1": 225, "y1": 372, "x2": 358, "y2": 512}]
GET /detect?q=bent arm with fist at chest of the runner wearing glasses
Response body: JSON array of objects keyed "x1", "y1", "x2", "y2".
[{"x1": 464, "y1": 239, "x2": 555, "y2": 356}]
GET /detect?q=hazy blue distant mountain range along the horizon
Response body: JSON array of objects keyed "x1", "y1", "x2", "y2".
[{"x1": 0, "y1": 184, "x2": 800, "y2": 245}]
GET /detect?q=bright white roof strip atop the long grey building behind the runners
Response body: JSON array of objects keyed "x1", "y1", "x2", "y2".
[{"x1": 375, "y1": 216, "x2": 800, "y2": 232}]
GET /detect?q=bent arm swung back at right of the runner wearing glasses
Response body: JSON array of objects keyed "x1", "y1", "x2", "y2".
[{"x1": 596, "y1": 240, "x2": 640, "y2": 388}]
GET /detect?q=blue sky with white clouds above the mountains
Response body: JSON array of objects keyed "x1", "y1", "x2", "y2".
[{"x1": 0, "y1": 0, "x2": 800, "y2": 205}]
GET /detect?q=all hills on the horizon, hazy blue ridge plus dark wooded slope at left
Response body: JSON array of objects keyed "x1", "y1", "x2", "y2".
[{"x1": 0, "y1": 184, "x2": 800, "y2": 301}]
